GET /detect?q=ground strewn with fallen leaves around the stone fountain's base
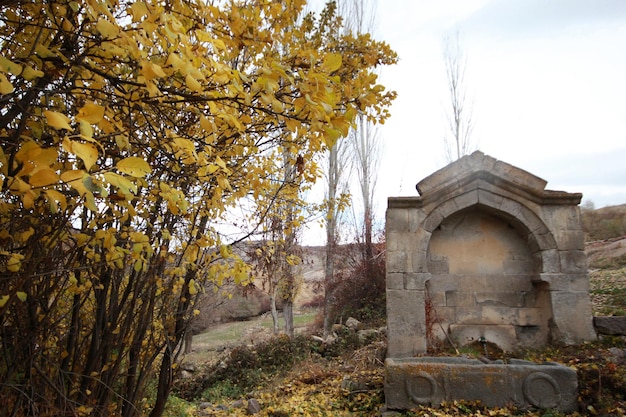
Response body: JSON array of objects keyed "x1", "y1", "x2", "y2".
[{"x1": 170, "y1": 328, "x2": 626, "y2": 417}]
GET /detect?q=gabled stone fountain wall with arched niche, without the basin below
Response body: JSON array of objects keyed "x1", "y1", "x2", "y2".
[{"x1": 386, "y1": 152, "x2": 596, "y2": 358}]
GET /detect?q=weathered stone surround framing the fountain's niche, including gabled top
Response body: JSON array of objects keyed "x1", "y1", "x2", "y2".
[{"x1": 386, "y1": 152, "x2": 595, "y2": 357}]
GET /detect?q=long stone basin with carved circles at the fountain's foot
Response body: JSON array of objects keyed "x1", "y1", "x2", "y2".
[{"x1": 385, "y1": 357, "x2": 578, "y2": 413}]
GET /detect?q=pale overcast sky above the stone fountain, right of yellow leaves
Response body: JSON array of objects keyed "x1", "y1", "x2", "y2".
[{"x1": 375, "y1": 0, "x2": 626, "y2": 208}]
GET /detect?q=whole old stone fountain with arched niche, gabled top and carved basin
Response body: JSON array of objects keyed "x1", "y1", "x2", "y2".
[{"x1": 385, "y1": 151, "x2": 596, "y2": 412}]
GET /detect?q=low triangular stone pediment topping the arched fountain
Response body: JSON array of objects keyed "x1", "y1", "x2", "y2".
[{"x1": 413, "y1": 151, "x2": 582, "y2": 204}]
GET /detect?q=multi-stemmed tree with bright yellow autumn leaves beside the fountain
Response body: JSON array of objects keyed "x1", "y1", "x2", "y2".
[{"x1": 0, "y1": 0, "x2": 396, "y2": 416}]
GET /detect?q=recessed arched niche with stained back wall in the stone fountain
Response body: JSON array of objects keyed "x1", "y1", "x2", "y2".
[{"x1": 424, "y1": 198, "x2": 554, "y2": 350}]
